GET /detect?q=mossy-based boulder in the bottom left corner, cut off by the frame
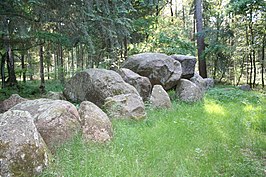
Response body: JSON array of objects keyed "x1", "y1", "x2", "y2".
[{"x1": 0, "y1": 110, "x2": 50, "y2": 177}]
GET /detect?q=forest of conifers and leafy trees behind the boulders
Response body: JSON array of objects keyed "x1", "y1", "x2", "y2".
[{"x1": 0, "y1": 0, "x2": 266, "y2": 91}]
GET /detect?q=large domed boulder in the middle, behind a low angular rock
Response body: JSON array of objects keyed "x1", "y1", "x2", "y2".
[{"x1": 64, "y1": 69, "x2": 139, "y2": 107}]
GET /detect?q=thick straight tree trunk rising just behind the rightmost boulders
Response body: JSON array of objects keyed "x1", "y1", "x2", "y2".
[{"x1": 196, "y1": 0, "x2": 207, "y2": 78}]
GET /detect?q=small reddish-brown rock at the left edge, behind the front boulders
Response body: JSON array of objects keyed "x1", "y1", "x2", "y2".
[{"x1": 0, "y1": 94, "x2": 27, "y2": 113}]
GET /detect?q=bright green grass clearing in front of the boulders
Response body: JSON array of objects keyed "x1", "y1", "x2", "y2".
[{"x1": 42, "y1": 88, "x2": 266, "y2": 177}]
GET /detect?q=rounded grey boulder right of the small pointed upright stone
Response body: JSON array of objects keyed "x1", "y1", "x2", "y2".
[{"x1": 176, "y1": 79, "x2": 204, "y2": 102}]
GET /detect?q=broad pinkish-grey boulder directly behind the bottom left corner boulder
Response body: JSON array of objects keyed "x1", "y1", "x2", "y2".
[{"x1": 11, "y1": 99, "x2": 80, "y2": 150}]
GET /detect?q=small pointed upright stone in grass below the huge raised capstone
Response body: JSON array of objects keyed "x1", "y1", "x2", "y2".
[{"x1": 150, "y1": 85, "x2": 172, "y2": 108}]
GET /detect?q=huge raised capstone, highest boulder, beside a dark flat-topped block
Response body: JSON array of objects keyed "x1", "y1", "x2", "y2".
[{"x1": 122, "y1": 53, "x2": 182, "y2": 90}]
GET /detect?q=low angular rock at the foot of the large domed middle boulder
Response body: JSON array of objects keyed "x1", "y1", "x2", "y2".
[{"x1": 104, "y1": 94, "x2": 146, "y2": 120}]
